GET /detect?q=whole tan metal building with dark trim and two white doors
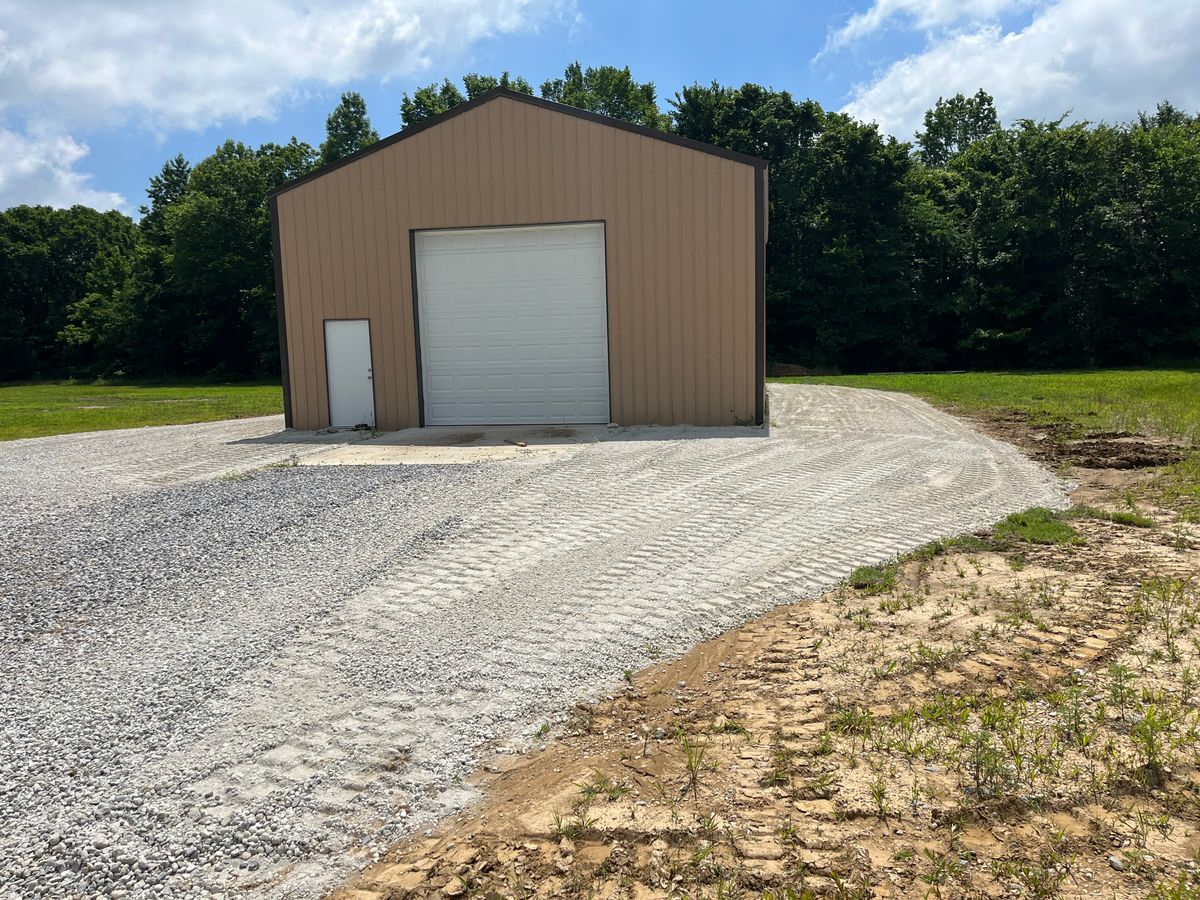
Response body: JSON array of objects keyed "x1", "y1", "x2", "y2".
[{"x1": 270, "y1": 89, "x2": 767, "y2": 431}]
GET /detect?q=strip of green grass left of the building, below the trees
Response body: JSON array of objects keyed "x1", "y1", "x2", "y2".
[{"x1": 0, "y1": 383, "x2": 283, "y2": 440}]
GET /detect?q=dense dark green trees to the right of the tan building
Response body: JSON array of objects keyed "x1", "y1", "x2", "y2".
[{"x1": 672, "y1": 84, "x2": 1200, "y2": 371}]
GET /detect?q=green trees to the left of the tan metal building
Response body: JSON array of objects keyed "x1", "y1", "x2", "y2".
[{"x1": 0, "y1": 138, "x2": 317, "y2": 380}]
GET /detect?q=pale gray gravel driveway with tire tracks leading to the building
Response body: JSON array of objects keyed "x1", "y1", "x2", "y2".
[{"x1": 0, "y1": 385, "x2": 1066, "y2": 896}]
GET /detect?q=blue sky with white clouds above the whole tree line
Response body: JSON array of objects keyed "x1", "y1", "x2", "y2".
[{"x1": 0, "y1": 0, "x2": 1200, "y2": 212}]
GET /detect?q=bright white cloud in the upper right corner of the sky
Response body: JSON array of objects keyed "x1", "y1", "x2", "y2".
[{"x1": 845, "y1": 0, "x2": 1200, "y2": 139}]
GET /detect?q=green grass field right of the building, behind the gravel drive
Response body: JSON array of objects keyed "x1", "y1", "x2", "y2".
[{"x1": 770, "y1": 370, "x2": 1200, "y2": 446}]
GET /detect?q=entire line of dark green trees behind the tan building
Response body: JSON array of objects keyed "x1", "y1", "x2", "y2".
[{"x1": 0, "y1": 64, "x2": 1200, "y2": 380}]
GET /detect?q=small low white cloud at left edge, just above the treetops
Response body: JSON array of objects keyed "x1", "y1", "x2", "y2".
[{"x1": 0, "y1": 127, "x2": 125, "y2": 210}]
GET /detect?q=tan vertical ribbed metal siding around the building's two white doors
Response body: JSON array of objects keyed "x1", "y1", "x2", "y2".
[{"x1": 277, "y1": 97, "x2": 758, "y2": 430}]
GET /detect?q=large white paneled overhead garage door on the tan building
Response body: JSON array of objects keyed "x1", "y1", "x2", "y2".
[{"x1": 416, "y1": 224, "x2": 608, "y2": 425}]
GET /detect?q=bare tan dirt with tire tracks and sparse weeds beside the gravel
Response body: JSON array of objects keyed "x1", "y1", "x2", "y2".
[{"x1": 335, "y1": 418, "x2": 1200, "y2": 900}]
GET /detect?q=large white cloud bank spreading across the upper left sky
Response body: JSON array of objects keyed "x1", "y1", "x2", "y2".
[{"x1": 0, "y1": 0, "x2": 575, "y2": 209}]
